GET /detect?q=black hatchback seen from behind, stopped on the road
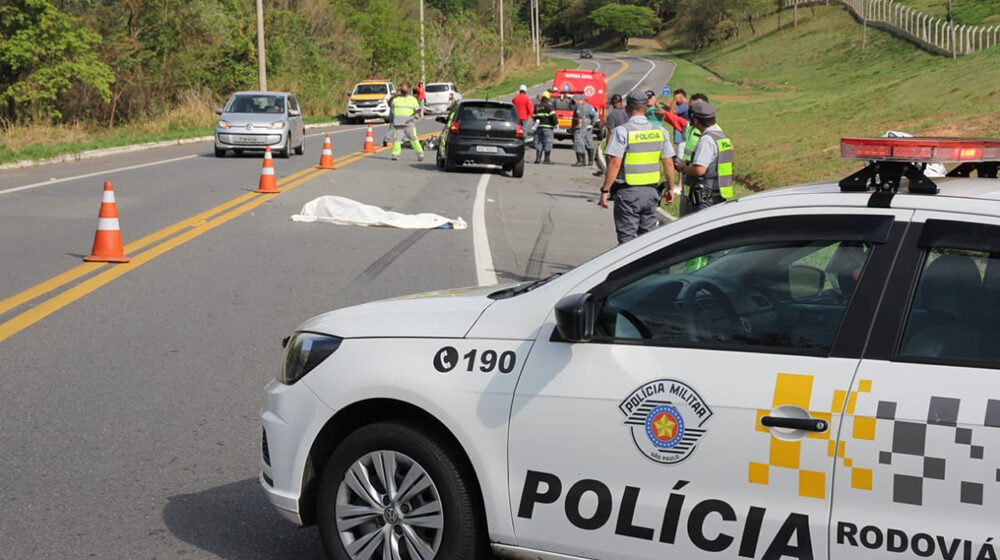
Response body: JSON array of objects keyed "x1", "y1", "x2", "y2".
[{"x1": 436, "y1": 99, "x2": 524, "y2": 177}]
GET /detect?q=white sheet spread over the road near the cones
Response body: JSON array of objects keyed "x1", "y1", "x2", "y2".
[{"x1": 292, "y1": 196, "x2": 468, "y2": 229}]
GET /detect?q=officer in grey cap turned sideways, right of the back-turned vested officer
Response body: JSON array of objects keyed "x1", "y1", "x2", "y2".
[{"x1": 678, "y1": 101, "x2": 735, "y2": 212}]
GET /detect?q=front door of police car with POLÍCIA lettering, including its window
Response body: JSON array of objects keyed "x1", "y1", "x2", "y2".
[{"x1": 509, "y1": 210, "x2": 902, "y2": 560}]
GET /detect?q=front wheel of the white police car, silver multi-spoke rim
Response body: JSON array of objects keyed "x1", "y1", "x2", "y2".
[{"x1": 318, "y1": 422, "x2": 487, "y2": 560}]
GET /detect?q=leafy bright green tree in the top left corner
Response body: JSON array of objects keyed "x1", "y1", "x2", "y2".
[{"x1": 0, "y1": 0, "x2": 115, "y2": 122}]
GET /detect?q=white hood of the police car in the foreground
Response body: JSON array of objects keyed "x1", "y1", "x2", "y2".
[{"x1": 298, "y1": 286, "x2": 502, "y2": 338}]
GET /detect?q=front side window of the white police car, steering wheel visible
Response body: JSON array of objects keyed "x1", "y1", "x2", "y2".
[{"x1": 595, "y1": 239, "x2": 872, "y2": 355}]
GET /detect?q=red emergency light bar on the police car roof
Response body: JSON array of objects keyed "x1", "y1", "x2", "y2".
[{"x1": 840, "y1": 138, "x2": 1000, "y2": 163}]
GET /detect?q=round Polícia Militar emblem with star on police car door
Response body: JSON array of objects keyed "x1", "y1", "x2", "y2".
[{"x1": 618, "y1": 379, "x2": 712, "y2": 465}]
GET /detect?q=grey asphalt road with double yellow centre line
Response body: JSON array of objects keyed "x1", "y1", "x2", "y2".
[{"x1": 0, "y1": 55, "x2": 672, "y2": 560}]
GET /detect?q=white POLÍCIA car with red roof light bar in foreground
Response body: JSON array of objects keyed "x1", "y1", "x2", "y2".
[{"x1": 260, "y1": 138, "x2": 1000, "y2": 560}]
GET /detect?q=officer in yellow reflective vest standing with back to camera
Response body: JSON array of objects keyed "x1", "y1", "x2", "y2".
[{"x1": 599, "y1": 91, "x2": 674, "y2": 244}]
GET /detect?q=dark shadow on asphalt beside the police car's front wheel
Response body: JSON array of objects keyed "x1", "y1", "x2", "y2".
[{"x1": 163, "y1": 478, "x2": 323, "y2": 560}]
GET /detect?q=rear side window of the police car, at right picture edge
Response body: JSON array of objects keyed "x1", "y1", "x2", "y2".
[{"x1": 900, "y1": 247, "x2": 1000, "y2": 364}]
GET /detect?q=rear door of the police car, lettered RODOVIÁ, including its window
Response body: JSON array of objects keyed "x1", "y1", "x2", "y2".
[{"x1": 831, "y1": 212, "x2": 1000, "y2": 560}]
